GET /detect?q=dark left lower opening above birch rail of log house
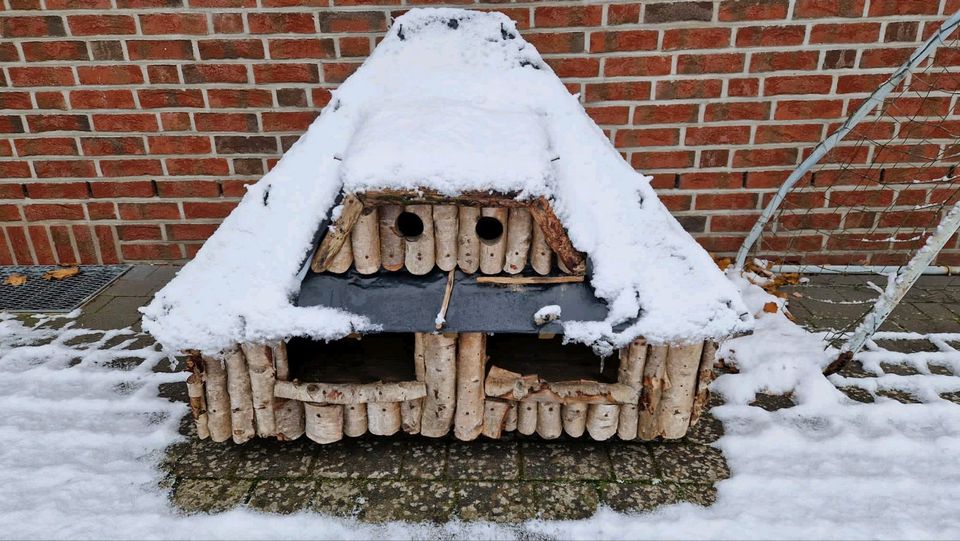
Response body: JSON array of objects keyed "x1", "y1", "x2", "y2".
[{"x1": 287, "y1": 333, "x2": 417, "y2": 383}]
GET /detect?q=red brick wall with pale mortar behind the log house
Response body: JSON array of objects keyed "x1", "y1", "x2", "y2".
[{"x1": 0, "y1": 0, "x2": 960, "y2": 264}]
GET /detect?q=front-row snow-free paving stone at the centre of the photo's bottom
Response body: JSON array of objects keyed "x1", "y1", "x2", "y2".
[{"x1": 454, "y1": 481, "x2": 537, "y2": 522}]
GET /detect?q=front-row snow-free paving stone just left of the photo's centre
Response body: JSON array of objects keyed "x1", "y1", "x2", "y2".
[{"x1": 360, "y1": 481, "x2": 455, "y2": 523}]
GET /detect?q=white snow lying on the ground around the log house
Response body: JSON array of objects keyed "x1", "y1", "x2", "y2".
[{"x1": 0, "y1": 272, "x2": 960, "y2": 539}]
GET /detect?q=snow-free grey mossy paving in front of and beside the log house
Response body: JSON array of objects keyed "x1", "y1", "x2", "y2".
[{"x1": 33, "y1": 266, "x2": 960, "y2": 522}]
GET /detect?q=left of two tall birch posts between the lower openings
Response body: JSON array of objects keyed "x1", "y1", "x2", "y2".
[{"x1": 420, "y1": 334, "x2": 457, "y2": 438}]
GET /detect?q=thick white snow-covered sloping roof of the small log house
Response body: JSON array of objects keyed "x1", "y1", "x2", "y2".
[{"x1": 142, "y1": 9, "x2": 752, "y2": 352}]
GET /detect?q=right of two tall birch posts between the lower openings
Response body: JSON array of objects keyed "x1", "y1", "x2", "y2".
[{"x1": 453, "y1": 332, "x2": 487, "y2": 441}]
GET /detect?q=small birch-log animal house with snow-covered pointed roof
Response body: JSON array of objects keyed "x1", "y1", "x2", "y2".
[{"x1": 144, "y1": 9, "x2": 750, "y2": 443}]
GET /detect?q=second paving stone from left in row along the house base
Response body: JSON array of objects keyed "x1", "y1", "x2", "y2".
[{"x1": 236, "y1": 438, "x2": 317, "y2": 479}]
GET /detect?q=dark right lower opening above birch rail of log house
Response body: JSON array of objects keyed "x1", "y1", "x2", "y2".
[{"x1": 487, "y1": 334, "x2": 620, "y2": 383}]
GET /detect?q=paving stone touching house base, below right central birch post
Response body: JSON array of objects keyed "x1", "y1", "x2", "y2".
[{"x1": 447, "y1": 441, "x2": 520, "y2": 480}]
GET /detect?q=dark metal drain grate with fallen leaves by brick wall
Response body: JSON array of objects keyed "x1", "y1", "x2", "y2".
[{"x1": 0, "y1": 265, "x2": 130, "y2": 312}]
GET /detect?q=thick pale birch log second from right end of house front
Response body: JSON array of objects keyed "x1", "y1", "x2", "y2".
[{"x1": 657, "y1": 342, "x2": 703, "y2": 440}]
